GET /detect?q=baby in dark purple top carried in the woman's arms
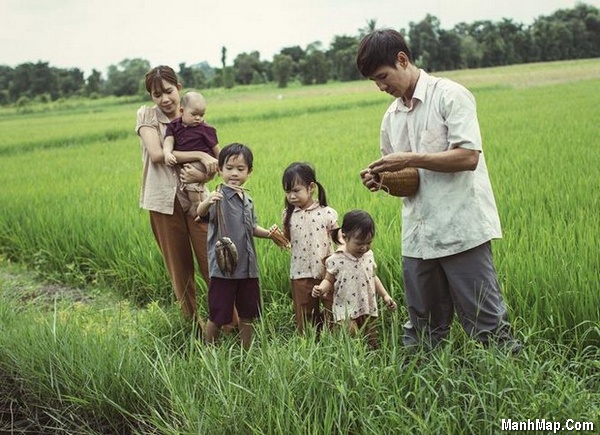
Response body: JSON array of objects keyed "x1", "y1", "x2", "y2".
[{"x1": 163, "y1": 92, "x2": 219, "y2": 217}]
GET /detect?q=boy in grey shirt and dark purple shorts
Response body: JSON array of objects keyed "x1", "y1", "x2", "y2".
[{"x1": 197, "y1": 143, "x2": 277, "y2": 349}]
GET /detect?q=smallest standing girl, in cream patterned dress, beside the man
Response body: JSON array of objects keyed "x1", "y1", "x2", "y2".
[{"x1": 312, "y1": 210, "x2": 396, "y2": 348}]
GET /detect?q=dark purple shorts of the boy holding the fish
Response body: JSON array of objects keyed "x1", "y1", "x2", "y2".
[{"x1": 208, "y1": 277, "x2": 260, "y2": 326}]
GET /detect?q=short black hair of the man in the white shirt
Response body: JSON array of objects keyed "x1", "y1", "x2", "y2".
[{"x1": 356, "y1": 29, "x2": 414, "y2": 77}]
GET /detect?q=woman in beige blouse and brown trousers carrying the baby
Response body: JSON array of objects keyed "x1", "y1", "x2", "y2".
[{"x1": 136, "y1": 66, "x2": 230, "y2": 327}]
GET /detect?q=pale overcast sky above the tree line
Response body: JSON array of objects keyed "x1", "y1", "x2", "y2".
[{"x1": 0, "y1": 0, "x2": 600, "y2": 75}]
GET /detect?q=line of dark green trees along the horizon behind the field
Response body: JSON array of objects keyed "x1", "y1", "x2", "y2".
[{"x1": 0, "y1": 3, "x2": 600, "y2": 106}]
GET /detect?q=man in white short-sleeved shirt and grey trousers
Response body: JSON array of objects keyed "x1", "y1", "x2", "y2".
[{"x1": 356, "y1": 29, "x2": 522, "y2": 352}]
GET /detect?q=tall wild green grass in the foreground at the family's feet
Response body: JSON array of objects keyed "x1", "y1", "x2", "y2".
[{"x1": 0, "y1": 268, "x2": 600, "y2": 434}]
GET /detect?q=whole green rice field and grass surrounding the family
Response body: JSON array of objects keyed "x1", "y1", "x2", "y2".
[{"x1": 0, "y1": 60, "x2": 600, "y2": 434}]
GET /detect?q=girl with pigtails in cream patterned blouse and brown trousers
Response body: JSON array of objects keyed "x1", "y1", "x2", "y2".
[{"x1": 282, "y1": 162, "x2": 338, "y2": 333}]
